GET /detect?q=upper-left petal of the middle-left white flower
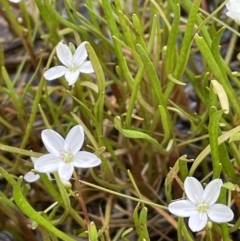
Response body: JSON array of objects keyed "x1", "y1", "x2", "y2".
[{"x1": 42, "y1": 129, "x2": 64, "y2": 155}]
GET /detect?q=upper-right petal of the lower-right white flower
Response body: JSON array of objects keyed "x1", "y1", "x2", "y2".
[{"x1": 202, "y1": 179, "x2": 222, "y2": 206}]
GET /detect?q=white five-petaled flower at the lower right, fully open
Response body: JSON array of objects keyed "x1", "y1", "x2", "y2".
[{"x1": 168, "y1": 177, "x2": 234, "y2": 232}]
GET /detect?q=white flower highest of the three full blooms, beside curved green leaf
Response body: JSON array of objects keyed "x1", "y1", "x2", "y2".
[{"x1": 43, "y1": 42, "x2": 94, "y2": 85}]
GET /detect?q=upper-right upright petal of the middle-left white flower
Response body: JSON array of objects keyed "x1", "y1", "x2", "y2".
[{"x1": 64, "y1": 125, "x2": 84, "y2": 155}]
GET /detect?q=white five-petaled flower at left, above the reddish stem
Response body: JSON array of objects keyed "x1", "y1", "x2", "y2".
[{"x1": 34, "y1": 125, "x2": 101, "y2": 183}]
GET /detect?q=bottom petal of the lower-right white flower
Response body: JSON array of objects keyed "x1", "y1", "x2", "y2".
[{"x1": 188, "y1": 211, "x2": 208, "y2": 232}]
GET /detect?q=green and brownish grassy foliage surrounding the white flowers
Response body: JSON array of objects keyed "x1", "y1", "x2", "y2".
[{"x1": 0, "y1": 0, "x2": 240, "y2": 241}]
